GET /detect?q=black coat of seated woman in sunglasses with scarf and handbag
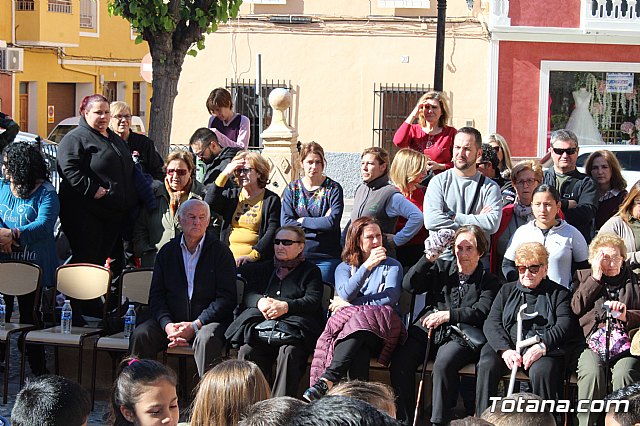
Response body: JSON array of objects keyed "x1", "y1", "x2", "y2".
[{"x1": 225, "y1": 260, "x2": 324, "y2": 352}]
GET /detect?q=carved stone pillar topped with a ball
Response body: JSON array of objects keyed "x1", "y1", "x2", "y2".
[{"x1": 262, "y1": 88, "x2": 300, "y2": 196}]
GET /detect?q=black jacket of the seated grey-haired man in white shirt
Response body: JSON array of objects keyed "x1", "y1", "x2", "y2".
[{"x1": 149, "y1": 231, "x2": 238, "y2": 330}]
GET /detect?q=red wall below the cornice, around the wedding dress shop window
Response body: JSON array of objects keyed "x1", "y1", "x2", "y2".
[{"x1": 497, "y1": 42, "x2": 640, "y2": 157}]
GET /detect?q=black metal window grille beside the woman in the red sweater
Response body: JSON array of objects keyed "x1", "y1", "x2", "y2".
[{"x1": 373, "y1": 83, "x2": 431, "y2": 158}]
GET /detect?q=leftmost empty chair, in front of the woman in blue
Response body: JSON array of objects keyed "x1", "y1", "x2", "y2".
[{"x1": 0, "y1": 260, "x2": 42, "y2": 404}]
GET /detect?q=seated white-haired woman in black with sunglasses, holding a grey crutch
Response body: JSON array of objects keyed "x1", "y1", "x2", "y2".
[{"x1": 476, "y1": 243, "x2": 576, "y2": 413}]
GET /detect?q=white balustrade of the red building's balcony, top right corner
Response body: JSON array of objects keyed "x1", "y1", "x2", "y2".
[{"x1": 582, "y1": 0, "x2": 640, "y2": 32}]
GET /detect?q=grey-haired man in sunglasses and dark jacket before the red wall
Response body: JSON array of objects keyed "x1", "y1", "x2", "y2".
[{"x1": 542, "y1": 129, "x2": 598, "y2": 243}]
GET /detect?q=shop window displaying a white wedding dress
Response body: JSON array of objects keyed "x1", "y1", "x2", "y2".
[{"x1": 549, "y1": 71, "x2": 640, "y2": 144}]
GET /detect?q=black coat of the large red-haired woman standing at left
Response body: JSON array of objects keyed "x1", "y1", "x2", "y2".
[{"x1": 57, "y1": 117, "x2": 138, "y2": 220}]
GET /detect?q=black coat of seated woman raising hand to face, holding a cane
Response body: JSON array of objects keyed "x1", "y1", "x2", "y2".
[{"x1": 402, "y1": 256, "x2": 500, "y2": 342}]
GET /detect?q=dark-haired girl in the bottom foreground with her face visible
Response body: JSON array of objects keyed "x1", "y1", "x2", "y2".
[{"x1": 109, "y1": 358, "x2": 180, "y2": 426}]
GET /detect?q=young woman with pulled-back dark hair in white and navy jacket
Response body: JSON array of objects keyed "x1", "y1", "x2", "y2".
[{"x1": 502, "y1": 184, "x2": 589, "y2": 288}]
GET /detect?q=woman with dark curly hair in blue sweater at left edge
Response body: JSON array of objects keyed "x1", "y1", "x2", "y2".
[{"x1": 0, "y1": 142, "x2": 60, "y2": 374}]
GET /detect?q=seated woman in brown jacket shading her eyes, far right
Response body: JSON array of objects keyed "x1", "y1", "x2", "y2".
[{"x1": 571, "y1": 232, "x2": 640, "y2": 426}]
